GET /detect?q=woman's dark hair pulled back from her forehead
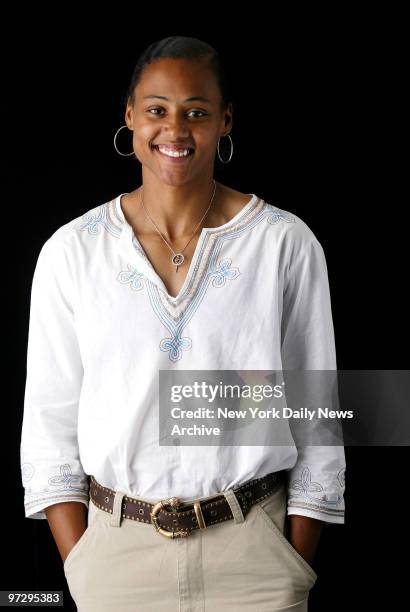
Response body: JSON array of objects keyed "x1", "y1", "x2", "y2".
[{"x1": 124, "y1": 36, "x2": 232, "y2": 112}]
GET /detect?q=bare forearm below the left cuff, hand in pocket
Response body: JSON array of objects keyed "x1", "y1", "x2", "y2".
[{"x1": 44, "y1": 502, "x2": 87, "y2": 562}]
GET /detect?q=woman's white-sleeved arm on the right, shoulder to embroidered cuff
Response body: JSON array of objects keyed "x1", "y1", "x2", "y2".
[{"x1": 281, "y1": 234, "x2": 346, "y2": 524}]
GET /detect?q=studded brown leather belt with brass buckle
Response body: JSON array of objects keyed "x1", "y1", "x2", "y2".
[{"x1": 89, "y1": 470, "x2": 286, "y2": 538}]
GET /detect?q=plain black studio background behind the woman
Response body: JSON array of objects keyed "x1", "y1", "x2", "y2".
[{"x1": 0, "y1": 5, "x2": 409, "y2": 612}]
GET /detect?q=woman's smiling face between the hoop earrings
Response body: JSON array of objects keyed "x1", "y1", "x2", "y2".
[{"x1": 125, "y1": 59, "x2": 232, "y2": 184}]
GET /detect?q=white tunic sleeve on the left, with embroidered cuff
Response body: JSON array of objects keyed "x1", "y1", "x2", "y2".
[{"x1": 20, "y1": 228, "x2": 89, "y2": 519}]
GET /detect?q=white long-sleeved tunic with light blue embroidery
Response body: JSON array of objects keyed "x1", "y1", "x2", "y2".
[{"x1": 20, "y1": 194, "x2": 345, "y2": 523}]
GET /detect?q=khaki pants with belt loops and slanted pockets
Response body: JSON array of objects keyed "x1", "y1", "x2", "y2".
[{"x1": 64, "y1": 484, "x2": 317, "y2": 612}]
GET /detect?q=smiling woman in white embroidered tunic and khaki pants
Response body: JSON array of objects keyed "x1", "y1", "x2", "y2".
[{"x1": 21, "y1": 37, "x2": 345, "y2": 612}]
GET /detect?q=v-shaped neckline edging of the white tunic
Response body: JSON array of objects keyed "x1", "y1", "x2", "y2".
[{"x1": 115, "y1": 192, "x2": 258, "y2": 303}]
